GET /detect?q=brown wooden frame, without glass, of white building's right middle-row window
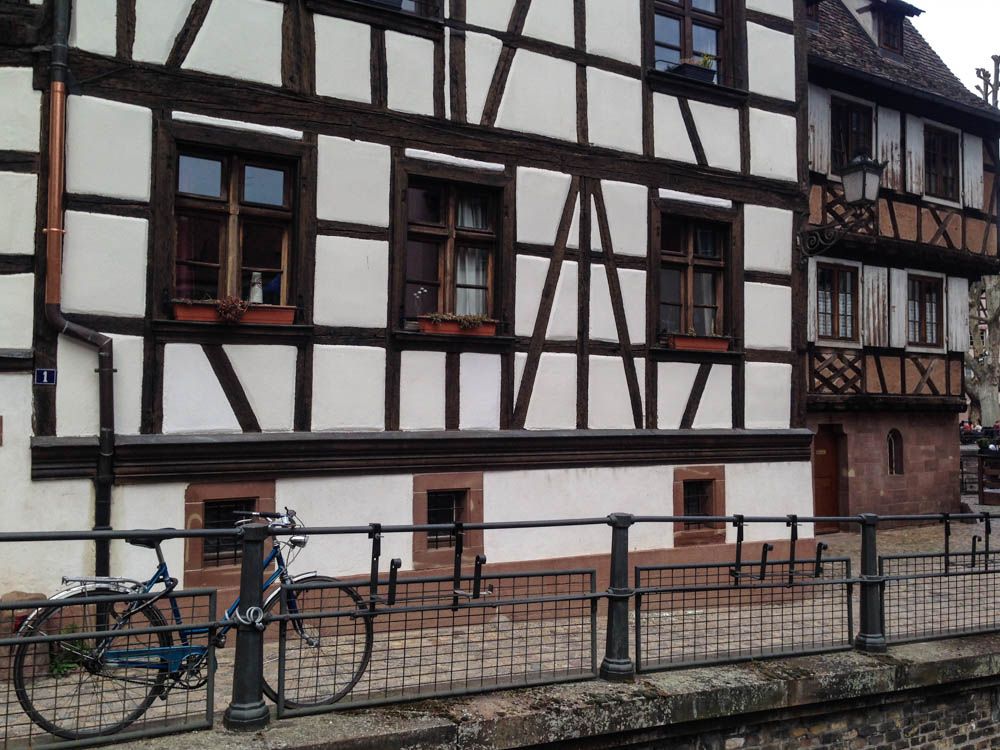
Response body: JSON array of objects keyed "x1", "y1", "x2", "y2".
[{"x1": 652, "y1": 208, "x2": 734, "y2": 342}]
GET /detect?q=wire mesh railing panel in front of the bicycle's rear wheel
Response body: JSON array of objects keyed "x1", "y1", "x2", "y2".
[{"x1": 0, "y1": 588, "x2": 215, "y2": 748}]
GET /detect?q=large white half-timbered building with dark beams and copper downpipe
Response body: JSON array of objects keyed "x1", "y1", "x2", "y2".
[{"x1": 0, "y1": 0, "x2": 813, "y2": 587}]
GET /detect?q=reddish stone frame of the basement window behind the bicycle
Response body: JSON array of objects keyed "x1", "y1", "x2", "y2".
[{"x1": 184, "y1": 481, "x2": 275, "y2": 592}]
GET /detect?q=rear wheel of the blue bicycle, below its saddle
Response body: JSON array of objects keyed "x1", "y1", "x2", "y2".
[{"x1": 12, "y1": 589, "x2": 172, "y2": 740}]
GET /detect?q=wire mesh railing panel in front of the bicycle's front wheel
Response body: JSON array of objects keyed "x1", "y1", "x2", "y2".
[{"x1": 277, "y1": 570, "x2": 599, "y2": 715}]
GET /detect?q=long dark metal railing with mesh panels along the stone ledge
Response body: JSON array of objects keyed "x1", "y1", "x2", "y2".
[{"x1": 0, "y1": 514, "x2": 1000, "y2": 747}]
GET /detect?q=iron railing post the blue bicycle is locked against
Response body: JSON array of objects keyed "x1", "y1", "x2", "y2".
[{"x1": 222, "y1": 523, "x2": 271, "y2": 731}]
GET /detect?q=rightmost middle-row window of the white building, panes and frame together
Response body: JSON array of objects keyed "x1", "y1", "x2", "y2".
[{"x1": 659, "y1": 215, "x2": 729, "y2": 336}]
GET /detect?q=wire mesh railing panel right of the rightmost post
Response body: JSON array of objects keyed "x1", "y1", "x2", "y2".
[{"x1": 879, "y1": 551, "x2": 1000, "y2": 643}]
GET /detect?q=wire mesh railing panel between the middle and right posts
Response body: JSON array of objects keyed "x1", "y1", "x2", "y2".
[{"x1": 635, "y1": 558, "x2": 854, "y2": 671}]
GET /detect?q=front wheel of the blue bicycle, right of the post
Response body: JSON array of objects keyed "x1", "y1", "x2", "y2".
[{"x1": 264, "y1": 576, "x2": 375, "y2": 709}]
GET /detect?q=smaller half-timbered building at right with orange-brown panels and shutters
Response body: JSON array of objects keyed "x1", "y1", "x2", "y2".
[{"x1": 805, "y1": 0, "x2": 1000, "y2": 514}]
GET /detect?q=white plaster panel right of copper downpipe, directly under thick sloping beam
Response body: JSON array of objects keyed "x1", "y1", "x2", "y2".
[{"x1": 66, "y1": 96, "x2": 153, "y2": 201}]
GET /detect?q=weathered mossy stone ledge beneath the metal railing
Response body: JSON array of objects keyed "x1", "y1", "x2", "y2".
[{"x1": 131, "y1": 635, "x2": 1000, "y2": 750}]
